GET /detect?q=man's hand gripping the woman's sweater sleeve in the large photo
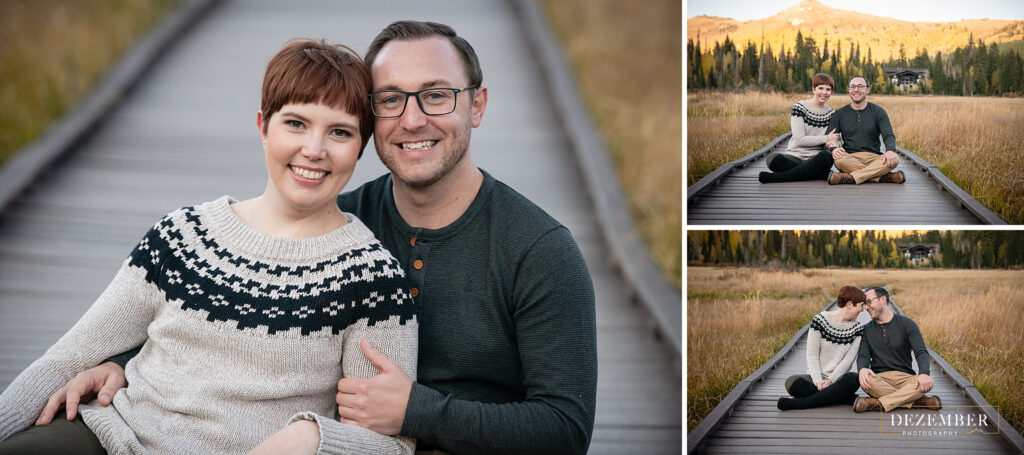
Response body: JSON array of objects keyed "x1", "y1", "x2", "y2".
[{"x1": 336, "y1": 339, "x2": 413, "y2": 435}]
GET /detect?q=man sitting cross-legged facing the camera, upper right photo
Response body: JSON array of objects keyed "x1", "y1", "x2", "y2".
[{"x1": 825, "y1": 75, "x2": 906, "y2": 184}]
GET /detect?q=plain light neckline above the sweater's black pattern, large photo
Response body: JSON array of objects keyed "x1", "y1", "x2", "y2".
[{"x1": 197, "y1": 196, "x2": 375, "y2": 262}]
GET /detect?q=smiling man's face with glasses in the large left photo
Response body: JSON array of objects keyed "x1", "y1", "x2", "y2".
[{"x1": 371, "y1": 37, "x2": 486, "y2": 188}]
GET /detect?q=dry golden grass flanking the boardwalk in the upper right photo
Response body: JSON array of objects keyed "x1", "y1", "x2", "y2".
[{"x1": 686, "y1": 92, "x2": 1024, "y2": 224}]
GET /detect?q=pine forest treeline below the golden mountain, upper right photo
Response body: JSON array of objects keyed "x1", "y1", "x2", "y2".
[{"x1": 686, "y1": 32, "x2": 1024, "y2": 96}]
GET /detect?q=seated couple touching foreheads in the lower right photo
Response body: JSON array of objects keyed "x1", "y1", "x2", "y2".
[{"x1": 778, "y1": 286, "x2": 942, "y2": 412}]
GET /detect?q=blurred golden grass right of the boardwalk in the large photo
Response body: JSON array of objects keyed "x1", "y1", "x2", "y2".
[{"x1": 541, "y1": 0, "x2": 683, "y2": 287}]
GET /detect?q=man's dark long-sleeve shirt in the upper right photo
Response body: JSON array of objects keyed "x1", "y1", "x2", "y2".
[{"x1": 827, "y1": 102, "x2": 896, "y2": 155}]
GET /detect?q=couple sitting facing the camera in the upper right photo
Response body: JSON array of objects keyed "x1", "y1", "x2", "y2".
[{"x1": 758, "y1": 73, "x2": 906, "y2": 184}]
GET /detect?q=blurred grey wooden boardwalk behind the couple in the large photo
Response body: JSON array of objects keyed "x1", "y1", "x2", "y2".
[{"x1": 0, "y1": 0, "x2": 682, "y2": 454}]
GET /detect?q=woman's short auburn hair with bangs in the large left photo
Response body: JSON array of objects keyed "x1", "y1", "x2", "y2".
[{"x1": 260, "y1": 38, "x2": 374, "y2": 157}]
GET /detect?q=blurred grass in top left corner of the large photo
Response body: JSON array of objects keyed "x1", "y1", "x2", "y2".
[{"x1": 0, "y1": 0, "x2": 183, "y2": 165}]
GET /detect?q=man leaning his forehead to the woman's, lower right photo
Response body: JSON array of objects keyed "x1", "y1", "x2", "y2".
[{"x1": 853, "y1": 287, "x2": 942, "y2": 412}]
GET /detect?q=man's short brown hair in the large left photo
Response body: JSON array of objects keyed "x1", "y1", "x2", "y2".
[{"x1": 366, "y1": 20, "x2": 483, "y2": 88}]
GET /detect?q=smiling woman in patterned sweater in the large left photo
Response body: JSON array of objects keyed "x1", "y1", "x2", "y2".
[{"x1": 0, "y1": 39, "x2": 418, "y2": 454}]
